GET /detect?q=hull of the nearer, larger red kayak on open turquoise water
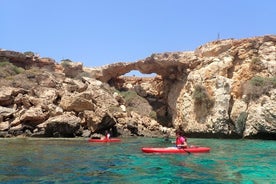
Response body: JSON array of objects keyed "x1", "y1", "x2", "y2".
[{"x1": 142, "y1": 146, "x2": 211, "y2": 153}]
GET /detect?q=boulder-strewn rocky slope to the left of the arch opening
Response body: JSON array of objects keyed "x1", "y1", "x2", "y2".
[{"x1": 0, "y1": 50, "x2": 173, "y2": 137}]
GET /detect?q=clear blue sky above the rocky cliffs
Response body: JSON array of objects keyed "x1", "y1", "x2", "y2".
[{"x1": 0, "y1": 0, "x2": 276, "y2": 67}]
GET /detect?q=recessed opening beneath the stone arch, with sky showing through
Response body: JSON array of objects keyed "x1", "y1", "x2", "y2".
[{"x1": 108, "y1": 70, "x2": 172, "y2": 127}]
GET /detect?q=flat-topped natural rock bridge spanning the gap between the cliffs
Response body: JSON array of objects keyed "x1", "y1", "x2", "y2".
[{"x1": 88, "y1": 52, "x2": 197, "y2": 82}]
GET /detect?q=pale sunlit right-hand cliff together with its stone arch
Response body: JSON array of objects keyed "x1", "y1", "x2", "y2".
[{"x1": 89, "y1": 35, "x2": 276, "y2": 138}]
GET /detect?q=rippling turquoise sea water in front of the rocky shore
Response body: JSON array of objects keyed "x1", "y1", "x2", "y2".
[{"x1": 0, "y1": 138, "x2": 276, "y2": 184}]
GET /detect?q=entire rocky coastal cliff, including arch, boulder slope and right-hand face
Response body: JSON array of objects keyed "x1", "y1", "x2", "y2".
[{"x1": 0, "y1": 35, "x2": 276, "y2": 139}]
